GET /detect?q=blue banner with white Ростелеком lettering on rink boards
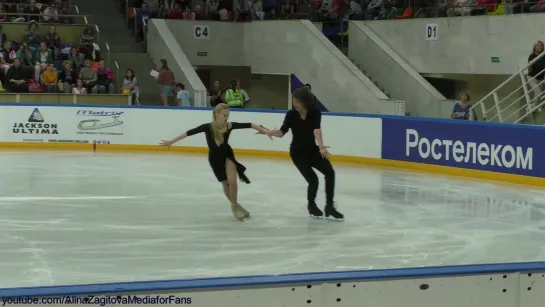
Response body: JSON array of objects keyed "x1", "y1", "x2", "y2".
[{"x1": 382, "y1": 118, "x2": 545, "y2": 177}]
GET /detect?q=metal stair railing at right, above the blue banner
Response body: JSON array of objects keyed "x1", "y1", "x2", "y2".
[{"x1": 471, "y1": 52, "x2": 545, "y2": 123}]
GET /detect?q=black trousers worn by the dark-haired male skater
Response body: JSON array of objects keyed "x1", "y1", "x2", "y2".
[{"x1": 290, "y1": 149, "x2": 335, "y2": 205}]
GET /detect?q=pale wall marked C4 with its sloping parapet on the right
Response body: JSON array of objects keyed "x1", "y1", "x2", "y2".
[{"x1": 167, "y1": 20, "x2": 395, "y2": 114}]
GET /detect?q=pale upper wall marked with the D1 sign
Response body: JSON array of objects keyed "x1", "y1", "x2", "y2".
[{"x1": 366, "y1": 14, "x2": 545, "y2": 75}]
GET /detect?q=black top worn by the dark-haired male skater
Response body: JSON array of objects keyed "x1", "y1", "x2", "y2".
[{"x1": 280, "y1": 108, "x2": 322, "y2": 151}]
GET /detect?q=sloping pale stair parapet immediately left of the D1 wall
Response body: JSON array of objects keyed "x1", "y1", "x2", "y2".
[{"x1": 348, "y1": 21, "x2": 454, "y2": 118}]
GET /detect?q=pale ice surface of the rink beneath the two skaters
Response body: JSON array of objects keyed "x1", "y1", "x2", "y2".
[{"x1": 0, "y1": 151, "x2": 545, "y2": 288}]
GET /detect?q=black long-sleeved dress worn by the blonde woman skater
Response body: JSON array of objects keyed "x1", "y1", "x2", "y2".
[{"x1": 187, "y1": 123, "x2": 252, "y2": 183}]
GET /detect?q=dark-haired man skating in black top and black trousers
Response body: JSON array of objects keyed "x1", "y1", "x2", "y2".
[{"x1": 267, "y1": 87, "x2": 344, "y2": 220}]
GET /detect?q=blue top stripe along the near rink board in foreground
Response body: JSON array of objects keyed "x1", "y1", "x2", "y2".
[{"x1": 0, "y1": 262, "x2": 545, "y2": 297}]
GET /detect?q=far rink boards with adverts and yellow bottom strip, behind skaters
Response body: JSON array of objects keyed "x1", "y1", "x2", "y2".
[{"x1": 0, "y1": 104, "x2": 545, "y2": 188}]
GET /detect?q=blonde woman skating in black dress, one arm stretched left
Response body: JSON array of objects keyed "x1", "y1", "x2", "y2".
[{"x1": 160, "y1": 103, "x2": 269, "y2": 220}]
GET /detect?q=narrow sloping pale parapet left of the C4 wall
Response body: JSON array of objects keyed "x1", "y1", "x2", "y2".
[{"x1": 148, "y1": 19, "x2": 207, "y2": 106}]
